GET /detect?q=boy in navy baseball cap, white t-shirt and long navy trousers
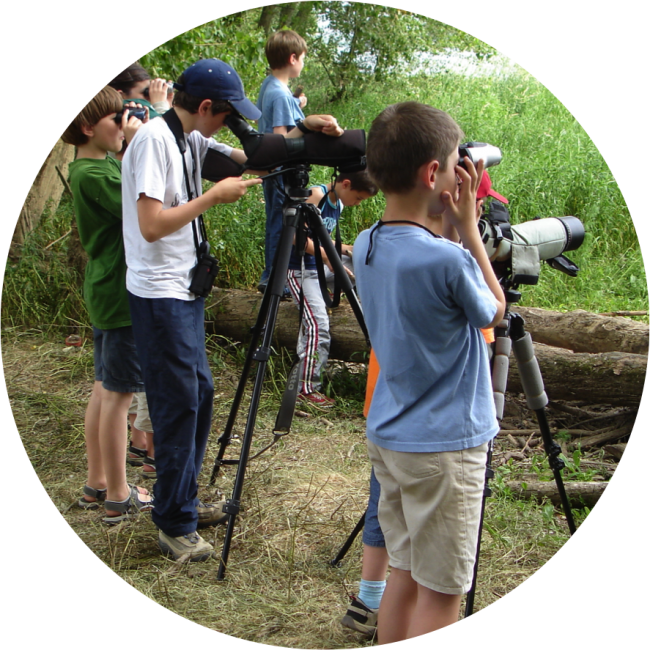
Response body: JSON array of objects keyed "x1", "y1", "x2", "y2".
[{"x1": 122, "y1": 59, "x2": 342, "y2": 561}]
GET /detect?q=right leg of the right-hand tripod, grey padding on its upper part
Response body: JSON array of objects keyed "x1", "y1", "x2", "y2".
[{"x1": 510, "y1": 314, "x2": 576, "y2": 537}]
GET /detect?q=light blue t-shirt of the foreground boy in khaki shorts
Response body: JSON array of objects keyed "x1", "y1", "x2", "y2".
[{"x1": 354, "y1": 225, "x2": 499, "y2": 452}]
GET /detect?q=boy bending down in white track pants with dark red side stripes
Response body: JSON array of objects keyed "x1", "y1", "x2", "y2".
[{"x1": 287, "y1": 171, "x2": 378, "y2": 408}]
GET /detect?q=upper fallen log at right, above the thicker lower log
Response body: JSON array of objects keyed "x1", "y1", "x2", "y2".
[{"x1": 512, "y1": 305, "x2": 650, "y2": 354}]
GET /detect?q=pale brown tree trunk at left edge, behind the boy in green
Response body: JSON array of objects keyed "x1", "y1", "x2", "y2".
[{"x1": 8, "y1": 139, "x2": 74, "y2": 260}]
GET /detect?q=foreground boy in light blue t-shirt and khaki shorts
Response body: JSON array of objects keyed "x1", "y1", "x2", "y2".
[{"x1": 354, "y1": 102, "x2": 505, "y2": 645}]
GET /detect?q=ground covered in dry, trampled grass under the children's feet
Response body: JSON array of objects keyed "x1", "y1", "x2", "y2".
[{"x1": 6, "y1": 331, "x2": 636, "y2": 649}]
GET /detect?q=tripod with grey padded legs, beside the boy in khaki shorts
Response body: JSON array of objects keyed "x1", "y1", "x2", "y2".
[{"x1": 330, "y1": 280, "x2": 576, "y2": 618}]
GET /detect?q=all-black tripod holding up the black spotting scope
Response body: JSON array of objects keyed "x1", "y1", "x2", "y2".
[{"x1": 210, "y1": 164, "x2": 368, "y2": 580}]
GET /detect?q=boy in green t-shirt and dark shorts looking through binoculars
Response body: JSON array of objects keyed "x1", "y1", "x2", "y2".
[{"x1": 61, "y1": 86, "x2": 153, "y2": 524}]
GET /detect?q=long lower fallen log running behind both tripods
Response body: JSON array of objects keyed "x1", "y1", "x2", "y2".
[{"x1": 206, "y1": 289, "x2": 648, "y2": 407}]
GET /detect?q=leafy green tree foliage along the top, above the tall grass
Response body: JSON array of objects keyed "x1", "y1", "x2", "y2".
[{"x1": 133, "y1": 5, "x2": 496, "y2": 101}]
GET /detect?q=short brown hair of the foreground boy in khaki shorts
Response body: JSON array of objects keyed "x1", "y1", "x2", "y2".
[{"x1": 366, "y1": 102, "x2": 463, "y2": 194}]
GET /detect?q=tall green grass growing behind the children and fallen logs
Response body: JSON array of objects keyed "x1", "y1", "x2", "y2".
[{"x1": 2, "y1": 73, "x2": 649, "y2": 332}]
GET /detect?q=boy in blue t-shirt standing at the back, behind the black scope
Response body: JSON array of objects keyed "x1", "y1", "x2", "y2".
[{"x1": 257, "y1": 29, "x2": 307, "y2": 293}]
